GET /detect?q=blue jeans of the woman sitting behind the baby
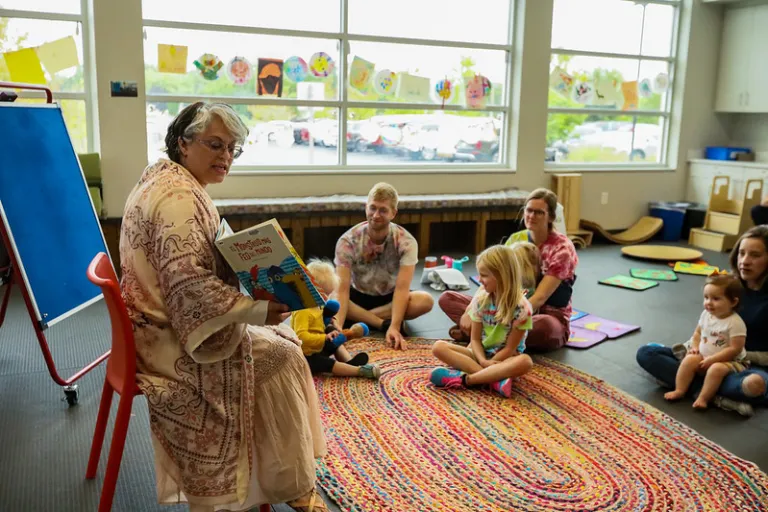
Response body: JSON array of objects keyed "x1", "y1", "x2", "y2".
[{"x1": 636, "y1": 345, "x2": 768, "y2": 405}]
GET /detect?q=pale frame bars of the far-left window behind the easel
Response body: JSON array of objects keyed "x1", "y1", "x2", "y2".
[{"x1": 0, "y1": 0, "x2": 97, "y2": 153}]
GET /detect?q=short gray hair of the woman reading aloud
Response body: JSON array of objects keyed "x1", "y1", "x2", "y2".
[{"x1": 165, "y1": 101, "x2": 248, "y2": 163}]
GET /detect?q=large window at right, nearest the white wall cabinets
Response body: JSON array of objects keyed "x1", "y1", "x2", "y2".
[{"x1": 545, "y1": 0, "x2": 680, "y2": 168}]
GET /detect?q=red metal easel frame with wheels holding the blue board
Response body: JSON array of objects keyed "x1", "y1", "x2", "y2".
[{"x1": 0, "y1": 82, "x2": 111, "y2": 405}]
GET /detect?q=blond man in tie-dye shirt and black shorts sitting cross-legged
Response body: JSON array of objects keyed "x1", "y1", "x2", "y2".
[{"x1": 334, "y1": 183, "x2": 434, "y2": 349}]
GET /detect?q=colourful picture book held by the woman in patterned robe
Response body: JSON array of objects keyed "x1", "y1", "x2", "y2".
[{"x1": 216, "y1": 219, "x2": 325, "y2": 311}]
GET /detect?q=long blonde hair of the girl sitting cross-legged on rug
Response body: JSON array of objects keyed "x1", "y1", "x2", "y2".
[{"x1": 477, "y1": 245, "x2": 523, "y2": 325}]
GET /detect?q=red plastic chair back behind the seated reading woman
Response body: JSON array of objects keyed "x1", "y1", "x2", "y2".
[{"x1": 87, "y1": 252, "x2": 136, "y2": 396}]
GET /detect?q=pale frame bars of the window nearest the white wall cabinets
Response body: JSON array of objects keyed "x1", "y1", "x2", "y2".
[{"x1": 544, "y1": 0, "x2": 683, "y2": 172}]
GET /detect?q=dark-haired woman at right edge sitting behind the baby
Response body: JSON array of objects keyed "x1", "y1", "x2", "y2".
[{"x1": 637, "y1": 225, "x2": 768, "y2": 416}]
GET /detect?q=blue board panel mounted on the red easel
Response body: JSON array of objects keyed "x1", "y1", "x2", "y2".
[{"x1": 0, "y1": 103, "x2": 109, "y2": 327}]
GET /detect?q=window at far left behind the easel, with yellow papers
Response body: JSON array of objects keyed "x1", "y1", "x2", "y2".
[{"x1": 0, "y1": 0, "x2": 93, "y2": 153}]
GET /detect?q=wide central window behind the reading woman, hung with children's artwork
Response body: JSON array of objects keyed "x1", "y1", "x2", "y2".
[{"x1": 144, "y1": 0, "x2": 512, "y2": 170}]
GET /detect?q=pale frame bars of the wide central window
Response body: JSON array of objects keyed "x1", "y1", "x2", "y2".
[{"x1": 142, "y1": 0, "x2": 516, "y2": 175}]
